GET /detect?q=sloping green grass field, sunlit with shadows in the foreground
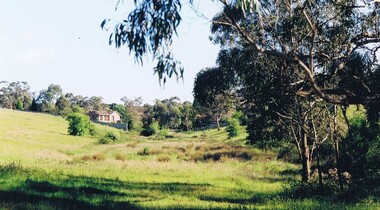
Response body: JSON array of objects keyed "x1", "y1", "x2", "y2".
[{"x1": 0, "y1": 109, "x2": 380, "y2": 209}]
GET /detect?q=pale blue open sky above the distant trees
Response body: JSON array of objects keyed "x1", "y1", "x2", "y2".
[{"x1": 0, "y1": 0, "x2": 220, "y2": 103}]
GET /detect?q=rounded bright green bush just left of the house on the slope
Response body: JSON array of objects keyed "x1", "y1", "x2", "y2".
[{"x1": 66, "y1": 113, "x2": 94, "y2": 136}]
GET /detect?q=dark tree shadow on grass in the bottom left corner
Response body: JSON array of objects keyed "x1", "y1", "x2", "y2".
[{"x1": 0, "y1": 166, "x2": 210, "y2": 209}]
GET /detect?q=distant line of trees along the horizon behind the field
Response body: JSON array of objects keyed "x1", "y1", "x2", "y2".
[{"x1": 0, "y1": 81, "x2": 241, "y2": 136}]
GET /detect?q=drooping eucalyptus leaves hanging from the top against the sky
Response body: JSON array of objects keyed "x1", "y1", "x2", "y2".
[{"x1": 101, "y1": 0, "x2": 183, "y2": 83}]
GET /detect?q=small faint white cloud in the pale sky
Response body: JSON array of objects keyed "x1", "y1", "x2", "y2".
[{"x1": 17, "y1": 49, "x2": 56, "y2": 62}]
